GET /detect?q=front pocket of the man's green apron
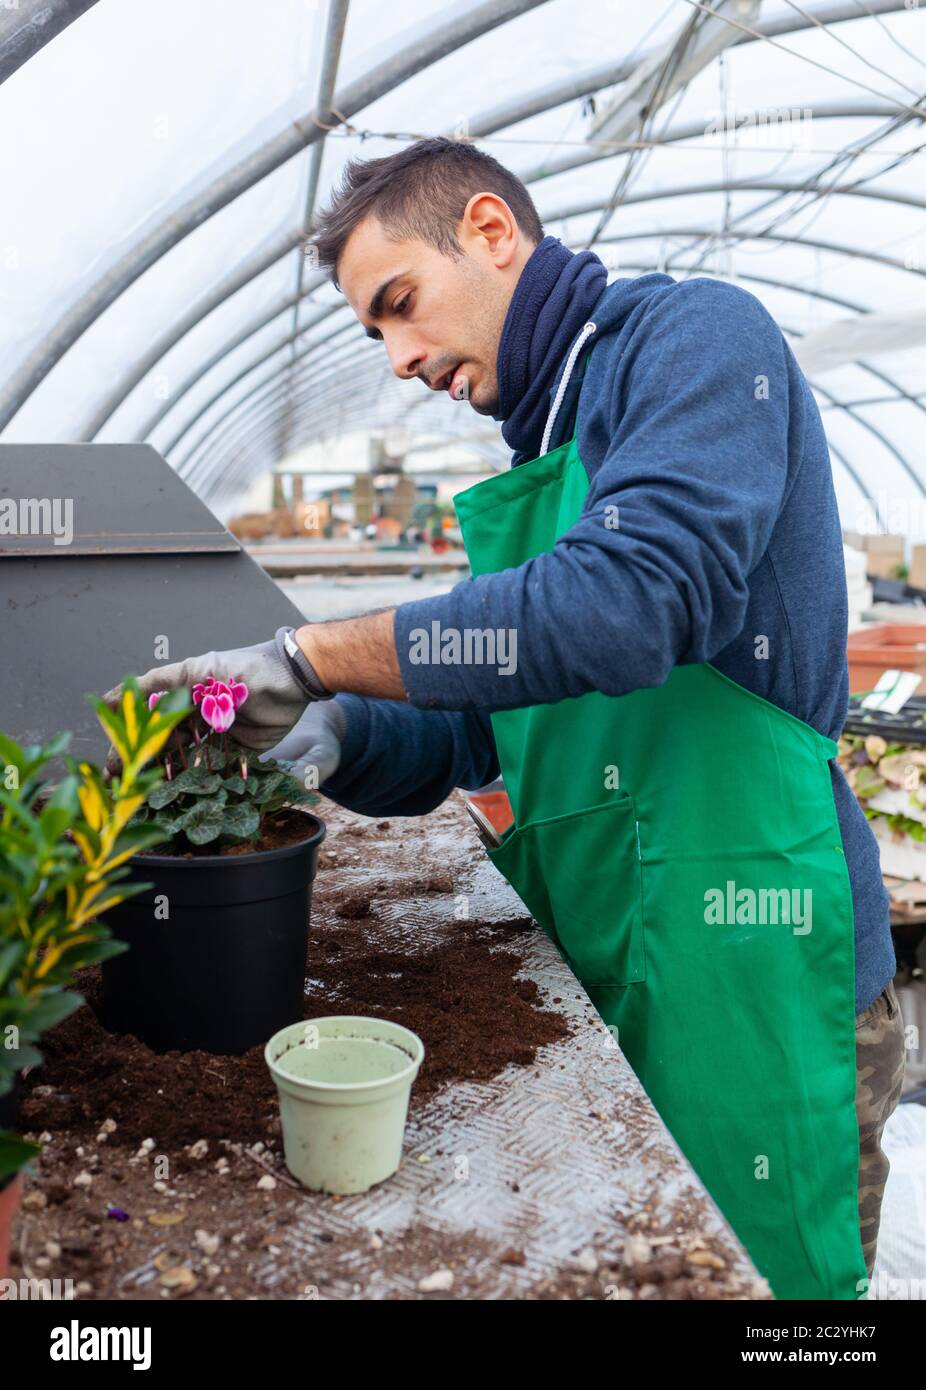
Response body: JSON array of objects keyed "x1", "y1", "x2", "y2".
[{"x1": 487, "y1": 792, "x2": 647, "y2": 987}]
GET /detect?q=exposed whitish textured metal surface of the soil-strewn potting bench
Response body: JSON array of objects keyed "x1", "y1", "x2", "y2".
[{"x1": 241, "y1": 792, "x2": 767, "y2": 1298}]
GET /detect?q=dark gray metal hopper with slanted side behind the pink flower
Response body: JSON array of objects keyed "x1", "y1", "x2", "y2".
[{"x1": 0, "y1": 443, "x2": 303, "y2": 762}]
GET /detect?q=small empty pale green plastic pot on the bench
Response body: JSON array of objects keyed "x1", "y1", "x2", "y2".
[{"x1": 264, "y1": 1015, "x2": 424, "y2": 1195}]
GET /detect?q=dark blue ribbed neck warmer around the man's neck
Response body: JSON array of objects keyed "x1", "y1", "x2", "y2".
[{"x1": 495, "y1": 236, "x2": 608, "y2": 461}]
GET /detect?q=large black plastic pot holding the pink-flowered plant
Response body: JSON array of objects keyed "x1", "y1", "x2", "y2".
[{"x1": 100, "y1": 812, "x2": 325, "y2": 1056}]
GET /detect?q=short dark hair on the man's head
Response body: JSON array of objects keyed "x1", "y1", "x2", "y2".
[{"x1": 309, "y1": 136, "x2": 544, "y2": 284}]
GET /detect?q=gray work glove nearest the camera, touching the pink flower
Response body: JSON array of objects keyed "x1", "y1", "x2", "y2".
[{"x1": 103, "y1": 627, "x2": 328, "y2": 752}]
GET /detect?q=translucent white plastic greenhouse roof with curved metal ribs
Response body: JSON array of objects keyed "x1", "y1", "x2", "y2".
[{"x1": 0, "y1": 0, "x2": 926, "y2": 537}]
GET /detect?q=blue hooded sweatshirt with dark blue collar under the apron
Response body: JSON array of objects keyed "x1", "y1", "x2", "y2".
[{"x1": 321, "y1": 236, "x2": 895, "y2": 1012}]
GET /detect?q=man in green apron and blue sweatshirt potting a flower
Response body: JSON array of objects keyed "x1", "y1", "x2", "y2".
[{"x1": 117, "y1": 139, "x2": 904, "y2": 1298}]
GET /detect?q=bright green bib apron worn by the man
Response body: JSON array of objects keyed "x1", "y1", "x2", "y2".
[{"x1": 453, "y1": 353, "x2": 866, "y2": 1300}]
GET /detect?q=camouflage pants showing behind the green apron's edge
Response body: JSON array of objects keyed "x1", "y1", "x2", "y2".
[{"x1": 855, "y1": 983, "x2": 904, "y2": 1279}]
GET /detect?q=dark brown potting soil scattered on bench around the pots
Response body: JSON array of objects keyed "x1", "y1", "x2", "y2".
[{"x1": 22, "y1": 917, "x2": 570, "y2": 1163}]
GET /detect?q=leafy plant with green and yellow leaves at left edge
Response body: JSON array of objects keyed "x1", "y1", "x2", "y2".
[{"x1": 0, "y1": 680, "x2": 192, "y2": 1184}]
